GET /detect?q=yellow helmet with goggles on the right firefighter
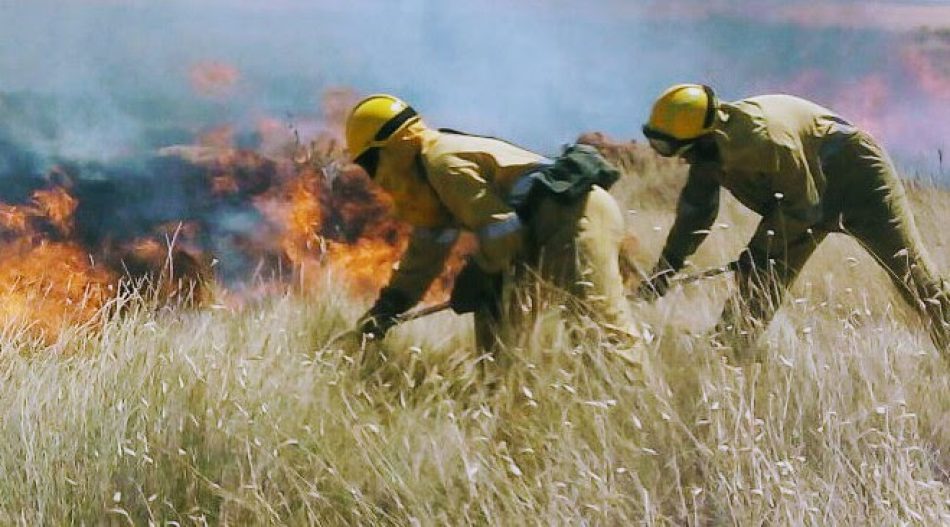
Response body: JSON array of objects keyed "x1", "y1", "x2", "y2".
[{"x1": 643, "y1": 84, "x2": 719, "y2": 154}]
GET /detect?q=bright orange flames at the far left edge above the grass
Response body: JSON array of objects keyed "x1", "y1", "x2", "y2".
[{"x1": 0, "y1": 177, "x2": 206, "y2": 340}]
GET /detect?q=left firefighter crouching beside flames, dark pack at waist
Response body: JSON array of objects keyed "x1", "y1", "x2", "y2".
[{"x1": 346, "y1": 95, "x2": 638, "y2": 368}]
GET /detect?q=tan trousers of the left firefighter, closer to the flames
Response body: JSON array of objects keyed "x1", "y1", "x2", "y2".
[{"x1": 475, "y1": 186, "x2": 644, "y2": 364}]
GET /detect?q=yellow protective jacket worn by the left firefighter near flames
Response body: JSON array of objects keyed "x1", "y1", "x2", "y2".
[{"x1": 376, "y1": 122, "x2": 549, "y2": 303}]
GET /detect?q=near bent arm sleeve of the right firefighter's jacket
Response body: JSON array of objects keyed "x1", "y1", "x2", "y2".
[{"x1": 749, "y1": 146, "x2": 821, "y2": 263}]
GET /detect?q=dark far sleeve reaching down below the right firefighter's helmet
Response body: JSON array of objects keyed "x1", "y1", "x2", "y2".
[{"x1": 660, "y1": 164, "x2": 719, "y2": 271}]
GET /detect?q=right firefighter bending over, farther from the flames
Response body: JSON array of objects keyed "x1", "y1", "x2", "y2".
[{"x1": 640, "y1": 84, "x2": 950, "y2": 358}]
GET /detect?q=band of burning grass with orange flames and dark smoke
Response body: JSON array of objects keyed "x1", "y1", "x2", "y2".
[{"x1": 0, "y1": 95, "x2": 464, "y2": 336}]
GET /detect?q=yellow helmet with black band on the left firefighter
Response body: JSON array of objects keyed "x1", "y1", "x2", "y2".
[{"x1": 346, "y1": 94, "x2": 419, "y2": 161}]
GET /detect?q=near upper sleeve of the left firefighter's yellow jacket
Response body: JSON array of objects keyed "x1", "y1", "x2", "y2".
[{"x1": 429, "y1": 156, "x2": 524, "y2": 273}]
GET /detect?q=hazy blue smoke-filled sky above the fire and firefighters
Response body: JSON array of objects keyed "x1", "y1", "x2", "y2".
[{"x1": 0, "y1": 0, "x2": 950, "y2": 169}]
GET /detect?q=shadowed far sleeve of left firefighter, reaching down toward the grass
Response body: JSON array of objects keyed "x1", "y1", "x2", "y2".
[{"x1": 389, "y1": 227, "x2": 459, "y2": 305}]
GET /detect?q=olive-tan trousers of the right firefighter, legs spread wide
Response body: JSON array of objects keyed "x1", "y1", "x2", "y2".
[{"x1": 719, "y1": 132, "x2": 950, "y2": 360}]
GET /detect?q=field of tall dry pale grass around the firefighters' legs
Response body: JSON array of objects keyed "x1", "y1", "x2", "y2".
[{"x1": 0, "y1": 151, "x2": 950, "y2": 525}]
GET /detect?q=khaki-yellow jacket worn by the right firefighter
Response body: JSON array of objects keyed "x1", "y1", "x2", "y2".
[{"x1": 662, "y1": 95, "x2": 856, "y2": 269}]
